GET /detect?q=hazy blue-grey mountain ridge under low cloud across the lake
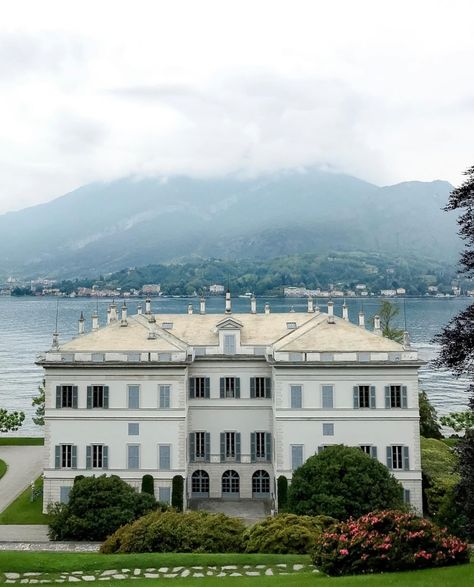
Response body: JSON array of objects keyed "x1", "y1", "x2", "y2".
[{"x1": 0, "y1": 169, "x2": 460, "y2": 277}]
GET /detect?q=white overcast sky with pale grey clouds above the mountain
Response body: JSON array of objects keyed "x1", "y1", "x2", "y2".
[{"x1": 0, "y1": 0, "x2": 474, "y2": 212}]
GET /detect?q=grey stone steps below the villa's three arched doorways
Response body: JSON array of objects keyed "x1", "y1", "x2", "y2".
[{"x1": 188, "y1": 499, "x2": 271, "y2": 526}]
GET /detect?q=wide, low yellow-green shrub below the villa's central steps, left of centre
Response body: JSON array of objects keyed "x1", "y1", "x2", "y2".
[{"x1": 101, "y1": 510, "x2": 245, "y2": 554}]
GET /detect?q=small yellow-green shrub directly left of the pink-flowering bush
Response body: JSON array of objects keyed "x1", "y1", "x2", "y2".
[{"x1": 244, "y1": 514, "x2": 336, "y2": 554}]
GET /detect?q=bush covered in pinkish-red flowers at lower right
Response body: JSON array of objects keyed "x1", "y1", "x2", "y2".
[{"x1": 312, "y1": 511, "x2": 469, "y2": 575}]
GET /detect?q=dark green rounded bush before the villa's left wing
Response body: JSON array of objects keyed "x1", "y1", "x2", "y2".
[{"x1": 48, "y1": 475, "x2": 157, "y2": 540}]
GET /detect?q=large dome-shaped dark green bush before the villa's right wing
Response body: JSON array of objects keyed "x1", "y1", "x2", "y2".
[{"x1": 288, "y1": 445, "x2": 404, "y2": 520}]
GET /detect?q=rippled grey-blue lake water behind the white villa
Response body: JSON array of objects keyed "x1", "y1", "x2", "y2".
[{"x1": 0, "y1": 297, "x2": 472, "y2": 435}]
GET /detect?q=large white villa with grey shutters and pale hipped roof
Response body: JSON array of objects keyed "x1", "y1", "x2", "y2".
[{"x1": 37, "y1": 292, "x2": 422, "y2": 512}]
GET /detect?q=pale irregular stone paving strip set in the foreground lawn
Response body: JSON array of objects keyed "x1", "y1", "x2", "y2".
[{"x1": 0, "y1": 563, "x2": 319, "y2": 585}]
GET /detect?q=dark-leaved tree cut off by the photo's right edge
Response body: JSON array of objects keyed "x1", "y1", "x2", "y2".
[{"x1": 435, "y1": 166, "x2": 474, "y2": 538}]
